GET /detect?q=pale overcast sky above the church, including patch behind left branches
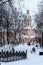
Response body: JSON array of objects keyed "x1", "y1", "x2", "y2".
[{"x1": 14, "y1": 0, "x2": 41, "y2": 27}]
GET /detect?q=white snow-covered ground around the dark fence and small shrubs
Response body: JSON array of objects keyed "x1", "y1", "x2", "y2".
[{"x1": 0, "y1": 44, "x2": 43, "y2": 65}]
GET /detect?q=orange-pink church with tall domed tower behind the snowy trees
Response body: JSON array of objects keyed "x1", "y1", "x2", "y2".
[{"x1": 21, "y1": 10, "x2": 40, "y2": 43}]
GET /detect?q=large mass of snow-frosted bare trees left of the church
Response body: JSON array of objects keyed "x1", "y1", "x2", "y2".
[{"x1": 0, "y1": 0, "x2": 23, "y2": 44}]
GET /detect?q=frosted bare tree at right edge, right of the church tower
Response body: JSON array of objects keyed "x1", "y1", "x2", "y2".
[{"x1": 35, "y1": 0, "x2": 43, "y2": 46}]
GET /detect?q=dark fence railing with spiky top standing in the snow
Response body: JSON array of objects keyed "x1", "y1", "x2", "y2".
[{"x1": 0, "y1": 50, "x2": 27, "y2": 62}]
